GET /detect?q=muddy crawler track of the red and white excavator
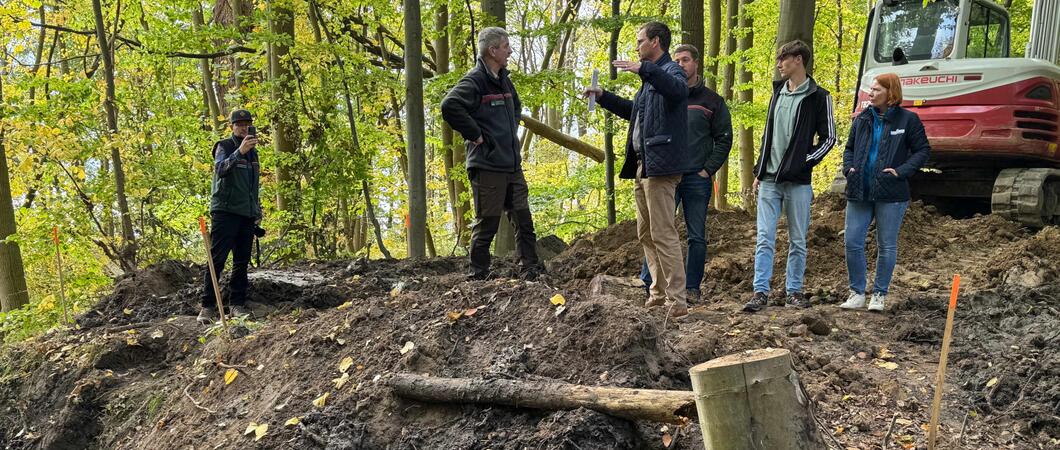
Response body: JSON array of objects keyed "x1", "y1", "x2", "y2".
[{"x1": 990, "y1": 168, "x2": 1060, "y2": 228}]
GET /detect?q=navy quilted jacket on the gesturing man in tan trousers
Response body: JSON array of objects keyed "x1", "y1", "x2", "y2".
[{"x1": 599, "y1": 53, "x2": 691, "y2": 179}]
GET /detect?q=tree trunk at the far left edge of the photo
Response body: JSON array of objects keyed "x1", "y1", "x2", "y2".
[{"x1": 0, "y1": 66, "x2": 30, "y2": 312}]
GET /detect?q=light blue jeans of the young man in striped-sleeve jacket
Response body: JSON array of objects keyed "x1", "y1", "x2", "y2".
[{"x1": 755, "y1": 181, "x2": 813, "y2": 294}]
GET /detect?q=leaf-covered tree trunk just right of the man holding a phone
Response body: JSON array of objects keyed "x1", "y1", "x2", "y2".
[{"x1": 268, "y1": 1, "x2": 300, "y2": 212}]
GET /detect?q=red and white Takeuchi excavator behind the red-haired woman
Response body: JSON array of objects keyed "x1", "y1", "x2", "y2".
[{"x1": 847, "y1": 0, "x2": 1060, "y2": 228}]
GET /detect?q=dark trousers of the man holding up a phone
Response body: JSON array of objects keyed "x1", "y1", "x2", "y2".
[{"x1": 202, "y1": 211, "x2": 254, "y2": 308}]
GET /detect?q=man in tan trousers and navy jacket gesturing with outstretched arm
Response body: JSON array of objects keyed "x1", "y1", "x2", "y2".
[{"x1": 585, "y1": 22, "x2": 689, "y2": 317}]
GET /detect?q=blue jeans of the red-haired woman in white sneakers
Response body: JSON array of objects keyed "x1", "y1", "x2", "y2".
[{"x1": 844, "y1": 200, "x2": 909, "y2": 295}]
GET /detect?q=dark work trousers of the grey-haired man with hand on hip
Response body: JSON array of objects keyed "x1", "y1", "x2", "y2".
[{"x1": 467, "y1": 168, "x2": 538, "y2": 275}]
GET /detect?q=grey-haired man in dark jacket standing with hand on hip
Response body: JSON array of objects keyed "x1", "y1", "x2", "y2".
[{"x1": 442, "y1": 26, "x2": 543, "y2": 280}]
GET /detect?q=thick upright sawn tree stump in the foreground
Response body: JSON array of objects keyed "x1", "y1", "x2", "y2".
[{"x1": 689, "y1": 348, "x2": 826, "y2": 450}]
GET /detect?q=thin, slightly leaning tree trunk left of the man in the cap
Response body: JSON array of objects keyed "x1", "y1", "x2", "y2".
[{"x1": 92, "y1": 0, "x2": 137, "y2": 271}]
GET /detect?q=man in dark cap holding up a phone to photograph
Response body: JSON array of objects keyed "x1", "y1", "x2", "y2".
[{"x1": 198, "y1": 109, "x2": 262, "y2": 325}]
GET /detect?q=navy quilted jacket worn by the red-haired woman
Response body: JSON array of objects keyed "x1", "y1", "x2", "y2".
[{"x1": 843, "y1": 106, "x2": 931, "y2": 202}]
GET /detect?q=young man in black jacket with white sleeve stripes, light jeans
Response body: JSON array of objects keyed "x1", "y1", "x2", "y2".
[{"x1": 743, "y1": 40, "x2": 835, "y2": 312}]
